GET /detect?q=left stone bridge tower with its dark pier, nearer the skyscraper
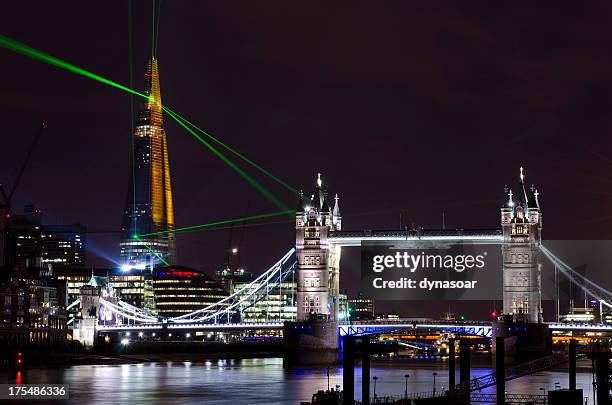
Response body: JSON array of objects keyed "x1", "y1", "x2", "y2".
[{"x1": 284, "y1": 173, "x2": 342, "y2": 364}]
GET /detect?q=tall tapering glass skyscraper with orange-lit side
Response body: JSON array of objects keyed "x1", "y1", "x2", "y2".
[{"x1": 119, "y1": 58, "x2": 176, "y2": 269}]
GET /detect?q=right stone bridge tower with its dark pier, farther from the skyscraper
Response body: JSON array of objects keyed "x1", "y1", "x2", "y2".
[{"x1": 493, "y1": 167, "x2": 552, "y2": 362}]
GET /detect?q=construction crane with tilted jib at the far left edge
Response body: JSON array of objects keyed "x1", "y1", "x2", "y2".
[{"x1": 0, "y1": 122, "x2": 47, "y2": 269}]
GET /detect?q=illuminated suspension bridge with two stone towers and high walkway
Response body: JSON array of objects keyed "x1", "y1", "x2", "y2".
[{"x1": 73, "y1": 170, "x2": 612, "y2": 360}]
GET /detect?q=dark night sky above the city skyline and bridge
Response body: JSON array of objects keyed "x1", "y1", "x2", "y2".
[{"x1": 0, "y1": 1, "x2": 612, "y2": 318}]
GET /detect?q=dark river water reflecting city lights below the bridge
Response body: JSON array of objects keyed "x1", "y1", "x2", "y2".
[{"x1": 0, "y1": 358, "x2": 593, "y2": 405}]
